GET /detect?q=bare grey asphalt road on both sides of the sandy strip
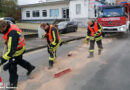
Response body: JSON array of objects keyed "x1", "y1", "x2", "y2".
[{"x1": 2, "y1": 36, "x2": 130, "y2": 90}]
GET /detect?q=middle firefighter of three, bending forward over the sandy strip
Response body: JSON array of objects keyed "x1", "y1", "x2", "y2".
[{"x1": 40, "y1": 22, "x2": 61, "y2": 69}]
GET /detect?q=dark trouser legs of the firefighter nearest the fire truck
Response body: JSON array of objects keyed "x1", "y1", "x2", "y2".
[{"x1": 89, "y1": 40, "x2": 103, "y2": 53}]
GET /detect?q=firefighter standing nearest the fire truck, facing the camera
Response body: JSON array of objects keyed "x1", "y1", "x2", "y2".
[{"x1": 86, "y1": 20, "x2": 103, "y2": 58}]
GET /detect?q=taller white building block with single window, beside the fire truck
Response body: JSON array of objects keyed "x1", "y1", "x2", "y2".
[{"x1": 69, "y1": 0, "x2": 99, "y2": 27}]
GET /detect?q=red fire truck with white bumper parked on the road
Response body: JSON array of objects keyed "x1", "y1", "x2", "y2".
[{"x1": 97, "y1": 3, "x2": 130, "y2": 33}]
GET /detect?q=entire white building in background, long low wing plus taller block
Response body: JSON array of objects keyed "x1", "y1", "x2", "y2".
[{"x1": 20, "y1": 0, "x2": 102, "y2": 26}]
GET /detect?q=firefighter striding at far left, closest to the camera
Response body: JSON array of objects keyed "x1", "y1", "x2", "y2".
[{"x1": 0, "y1": 20, "x2": 35, "y2": 90}]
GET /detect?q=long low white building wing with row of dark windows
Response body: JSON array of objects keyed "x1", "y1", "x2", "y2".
[{"x1": 21, "y1": 1, "x2": 69, "y2": 22}]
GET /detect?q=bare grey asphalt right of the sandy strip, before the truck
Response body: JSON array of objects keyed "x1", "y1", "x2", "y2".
[{"x1": 65, "y1": 36, "x2": 130, "y2": 90}]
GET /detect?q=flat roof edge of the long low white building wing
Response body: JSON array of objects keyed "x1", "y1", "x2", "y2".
[{"x1": 19, "y1": 0, "x2": 69, "y2": 8}]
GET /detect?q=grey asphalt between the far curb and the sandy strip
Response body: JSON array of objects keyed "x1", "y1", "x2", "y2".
[{"x1": 2, "y1": 40, "x2": 82, "y2": 86}]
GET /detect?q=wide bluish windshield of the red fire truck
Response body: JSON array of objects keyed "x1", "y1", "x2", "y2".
[{"x1": 100, "y1": 7, "x2": 125, "y2": 17}]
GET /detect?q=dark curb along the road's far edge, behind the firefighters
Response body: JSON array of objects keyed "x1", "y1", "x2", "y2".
[{"x1": 25, "y1": 36, "x2": 85, "y2": 53}]
